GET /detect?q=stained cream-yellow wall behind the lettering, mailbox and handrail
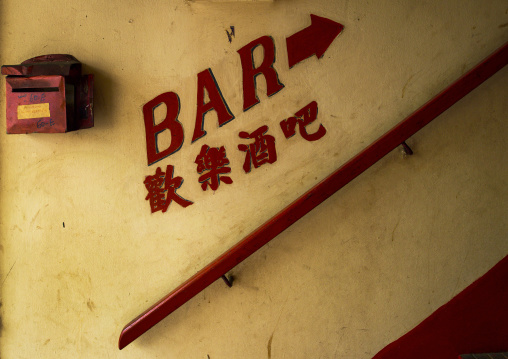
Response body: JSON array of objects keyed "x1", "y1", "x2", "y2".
[{"x1": 0, "y1": 0, "x2": 508, "y2": 359}]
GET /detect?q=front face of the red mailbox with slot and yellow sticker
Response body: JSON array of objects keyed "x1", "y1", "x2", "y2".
[{"x1": 6, "y1": 75, "x2": 67, "y2": 134}]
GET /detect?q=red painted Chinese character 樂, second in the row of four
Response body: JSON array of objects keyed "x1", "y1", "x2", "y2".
[{"x1": 194, "y1": 145, "x2": 233, "y2": 191}]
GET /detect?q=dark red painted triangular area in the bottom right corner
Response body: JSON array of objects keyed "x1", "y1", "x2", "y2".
[{"x1": 373, "y1": 256, "x2": 508, "y2": 359}]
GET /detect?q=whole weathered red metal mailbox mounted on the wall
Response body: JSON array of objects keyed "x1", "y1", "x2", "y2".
[{"x1": 2, "y1": 55, "x2": 94, "y2": 133}]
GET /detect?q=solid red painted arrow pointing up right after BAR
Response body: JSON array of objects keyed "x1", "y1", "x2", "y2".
[{"x1": 286, "y1": 14, "x2": 344, "y2": 68}]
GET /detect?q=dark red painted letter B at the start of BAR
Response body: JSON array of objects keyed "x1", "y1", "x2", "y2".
[{"x1": 143, "y1": 92, "x2": 183, "y2": 166}]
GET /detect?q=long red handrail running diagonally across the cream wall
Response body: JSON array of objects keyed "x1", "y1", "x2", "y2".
[{"x1": 118, "y1": 43, "x2": 508, "y2": 349}]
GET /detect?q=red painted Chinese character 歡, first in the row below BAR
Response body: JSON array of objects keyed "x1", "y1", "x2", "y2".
[{"x1": 143, "y1": 165, "x2": 193, "y2": 213}]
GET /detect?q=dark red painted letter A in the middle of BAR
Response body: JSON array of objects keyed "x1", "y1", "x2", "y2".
[{"x1": 192, "y1": 69, "x2": 235, "y2": 142}]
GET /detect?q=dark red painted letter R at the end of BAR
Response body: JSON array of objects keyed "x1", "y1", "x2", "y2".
[{"x1": 238, "y1": 36, "x2": 284, "y2": 111}]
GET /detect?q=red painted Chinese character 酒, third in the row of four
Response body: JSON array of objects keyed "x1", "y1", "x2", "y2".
[{"x1": 238, "y1": 126, "x2": 277, "y2": 173}]
